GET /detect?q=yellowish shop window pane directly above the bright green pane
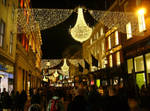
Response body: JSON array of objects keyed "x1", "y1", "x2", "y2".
[{"x1": 134, "y1": 56, "x2": 144, "y2": 72}]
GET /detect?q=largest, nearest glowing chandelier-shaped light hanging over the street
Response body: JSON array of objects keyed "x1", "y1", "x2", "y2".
[{"x1": 70, "y1": 8, "x2": 92, "y2": 42}]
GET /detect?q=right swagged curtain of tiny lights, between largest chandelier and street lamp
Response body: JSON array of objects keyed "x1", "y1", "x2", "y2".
[{"x1": 89, "y1": 10, "x2": 141, "y2": 35}]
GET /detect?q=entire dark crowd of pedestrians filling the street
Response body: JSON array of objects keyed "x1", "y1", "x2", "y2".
[{"x1": 0, "y1": 83, "x2": 150, "y2": 111}]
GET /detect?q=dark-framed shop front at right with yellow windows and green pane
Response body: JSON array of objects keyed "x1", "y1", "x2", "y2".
[{"x1": 125, "y1": 39, "x2": 150, "y2": 88}]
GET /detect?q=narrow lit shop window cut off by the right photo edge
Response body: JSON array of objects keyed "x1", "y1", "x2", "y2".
[{"x1": 145, "y1": 53, "x2": 150, "y2": 83}]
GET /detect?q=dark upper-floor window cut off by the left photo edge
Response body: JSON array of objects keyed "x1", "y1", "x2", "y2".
[{"x1": 0, "y1": 20, "x2": 5, "y2": 47}]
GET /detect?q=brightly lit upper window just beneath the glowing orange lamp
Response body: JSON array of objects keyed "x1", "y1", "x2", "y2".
[{"x1": 138, "y1": 14, "x2": 146, "y2": 32}]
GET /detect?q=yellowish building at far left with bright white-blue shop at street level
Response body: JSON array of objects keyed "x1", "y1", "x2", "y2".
[{"x1": 0, "y1": 0, "x2": 18, "y2": 93}]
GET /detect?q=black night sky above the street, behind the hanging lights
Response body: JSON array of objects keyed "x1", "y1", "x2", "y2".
[{"x1": 31, "y1": 0, "x2": 104, "y2": 59}]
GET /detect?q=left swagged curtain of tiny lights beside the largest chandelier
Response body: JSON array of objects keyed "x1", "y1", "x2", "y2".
[{"x1": 17, "y1": 9, "x2": 73, "y2": 33}]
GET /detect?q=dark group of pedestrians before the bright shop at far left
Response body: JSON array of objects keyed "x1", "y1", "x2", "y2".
[{"x1": 0, "y1": 88, "x2": 27, "y2": 111}]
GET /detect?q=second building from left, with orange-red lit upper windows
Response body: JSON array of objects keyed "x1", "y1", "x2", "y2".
[{"x1": 15, "y1": 0, "x2": 42, "y2": 92}]
